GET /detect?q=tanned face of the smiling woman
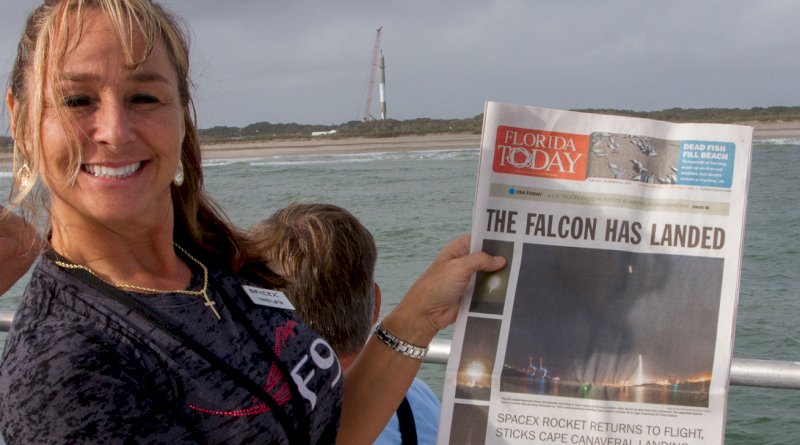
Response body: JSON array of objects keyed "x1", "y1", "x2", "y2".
[{"x1": 35, "y1": 12, "x2": 185, "y2": 230}]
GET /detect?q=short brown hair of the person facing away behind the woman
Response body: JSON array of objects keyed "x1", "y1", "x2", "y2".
[{"x1": 251, "y1": 203, "x2": 379, "y2": 356}]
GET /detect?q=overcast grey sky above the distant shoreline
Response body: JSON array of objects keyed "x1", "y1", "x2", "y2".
[{"x1": 0, "y1": 0, "x2": 800, "y2": 128}]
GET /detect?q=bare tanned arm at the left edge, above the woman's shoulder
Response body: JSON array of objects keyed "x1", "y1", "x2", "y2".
[{"x1": 0, "y1": 206, "x2": 41, "y2": 295}]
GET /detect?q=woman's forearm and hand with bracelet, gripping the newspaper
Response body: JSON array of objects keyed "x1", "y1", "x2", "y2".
[{"x1": 337, "y1": 235, "x2": 505, "y2": 444}]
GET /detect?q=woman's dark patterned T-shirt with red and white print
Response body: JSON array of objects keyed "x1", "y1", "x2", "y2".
[{"x1": 0, "y1": 254, "x2": 343, "y2": 445}]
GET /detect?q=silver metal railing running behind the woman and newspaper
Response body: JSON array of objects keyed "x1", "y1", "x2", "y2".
[{"x1": 0, "y1": 311, "x2": 800, "y2": 389}]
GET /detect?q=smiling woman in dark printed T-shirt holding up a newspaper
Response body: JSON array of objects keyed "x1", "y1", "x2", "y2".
[{"x1": 0, "y1": 0, "x2": 502, "y2": 444}]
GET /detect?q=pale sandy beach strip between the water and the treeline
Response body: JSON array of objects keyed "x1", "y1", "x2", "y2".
[{"x1": 0, "y1": 121, "x2": 800, "y2": 163}]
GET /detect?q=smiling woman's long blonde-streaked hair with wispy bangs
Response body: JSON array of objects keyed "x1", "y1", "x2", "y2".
[{"x1": 9, "y1": 0, "x2": 244, "y2": 271}]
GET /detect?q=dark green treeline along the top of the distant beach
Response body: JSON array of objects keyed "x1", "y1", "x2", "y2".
[{"x1": 200, "y1": 107, "x2": 800, "y2": 143}]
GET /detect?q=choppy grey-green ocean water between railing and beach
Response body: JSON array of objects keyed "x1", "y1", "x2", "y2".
[{"x1": 0, "y1": 139, "x2": 800, "y2": 445}]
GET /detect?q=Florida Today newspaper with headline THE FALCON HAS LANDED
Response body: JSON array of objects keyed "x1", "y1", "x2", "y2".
[{"x1": 438, "y1": 102, "x2": 753, "y2": 445}]
